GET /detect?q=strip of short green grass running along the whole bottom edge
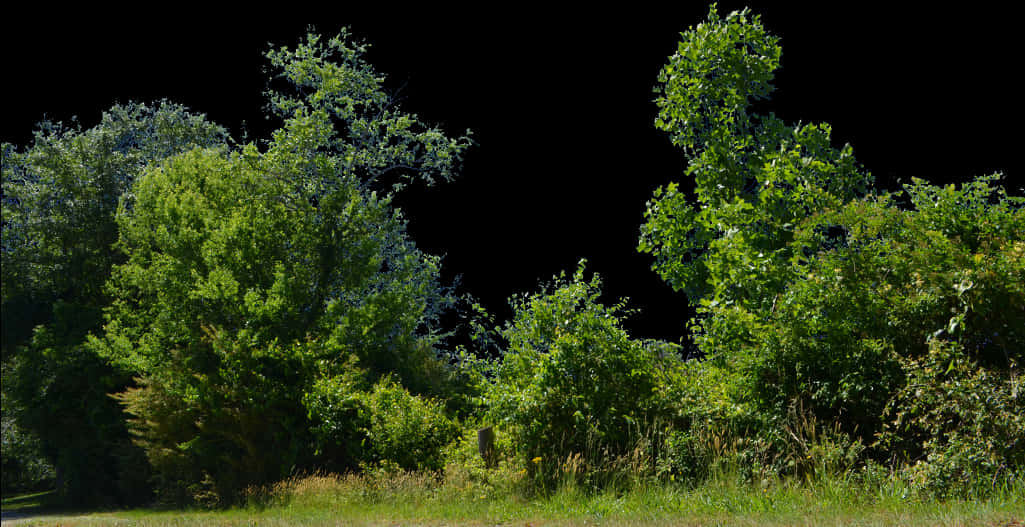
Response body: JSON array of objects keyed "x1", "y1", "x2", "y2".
[{"x1": 3, "y1": 473, "x2": 1025, "y2": 527}]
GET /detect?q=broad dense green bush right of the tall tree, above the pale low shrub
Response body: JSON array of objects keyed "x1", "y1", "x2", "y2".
[{"x1": 733, "y1": 177, "x2": 1025, "y2": 432}]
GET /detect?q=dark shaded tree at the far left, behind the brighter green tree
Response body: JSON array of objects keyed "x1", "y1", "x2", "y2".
[{"x1": 2, "y1": 103, "x2": 227, "y2": 504}]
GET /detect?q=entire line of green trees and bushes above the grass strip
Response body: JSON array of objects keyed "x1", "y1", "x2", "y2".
[{"x1": 2, "y1": 7, "x2": 1025, "y2": 504}]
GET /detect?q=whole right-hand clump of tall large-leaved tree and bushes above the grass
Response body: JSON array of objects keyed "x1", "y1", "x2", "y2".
[{"x1": 640, "y1": 6, "x2": 1025, "y2": 492}]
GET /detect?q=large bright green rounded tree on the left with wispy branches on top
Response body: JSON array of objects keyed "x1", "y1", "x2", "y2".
[{"x1": 91, "y1": 32, "x2": 469, "y2": 500}]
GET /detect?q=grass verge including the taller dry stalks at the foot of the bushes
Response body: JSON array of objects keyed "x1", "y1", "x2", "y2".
[{"x1": 5, "y1": 420, "x2": 1025, "y2": 527}]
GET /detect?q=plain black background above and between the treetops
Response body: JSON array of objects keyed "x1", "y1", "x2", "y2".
[{"x1": 0, "y1": 6, "x2": 1025, "y2": 340}]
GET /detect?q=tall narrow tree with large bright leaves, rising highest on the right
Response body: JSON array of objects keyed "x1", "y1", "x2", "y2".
[{"x1": 639, "y1": 5, "x2": 871, "y2": 315}]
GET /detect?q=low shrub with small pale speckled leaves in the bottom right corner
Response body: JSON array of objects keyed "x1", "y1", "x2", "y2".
[{"x1": 878, "y1": 339, "x2": 1025, "y2": 498}]
